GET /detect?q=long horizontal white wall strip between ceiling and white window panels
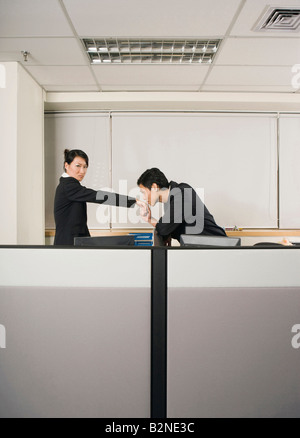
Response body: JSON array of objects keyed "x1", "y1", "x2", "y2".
[{"x1": 45, "y1": 91, "x2": 300, "y2": 112}]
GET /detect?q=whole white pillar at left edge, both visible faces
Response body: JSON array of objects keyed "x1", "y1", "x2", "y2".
[{"x1": 0, "y1": 62, "x2": 44, "y2": 245}]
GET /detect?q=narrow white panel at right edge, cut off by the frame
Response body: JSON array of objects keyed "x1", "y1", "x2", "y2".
[{"x1": 279, "y1": 115, "x2": 300, "y2": 228}]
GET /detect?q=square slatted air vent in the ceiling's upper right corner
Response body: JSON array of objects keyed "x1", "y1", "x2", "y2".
[{"x1": 253, "y1": 6, "x2": 300, "y2": 32}]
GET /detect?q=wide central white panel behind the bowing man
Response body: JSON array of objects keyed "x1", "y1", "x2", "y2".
[{"x1": 112, "y1": 112, "x2": 278, "y2": 228}]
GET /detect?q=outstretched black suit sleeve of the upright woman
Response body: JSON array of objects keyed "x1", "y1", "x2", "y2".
[{"x1": 65, "y1": 178, "x2": 136, "y2": 208}]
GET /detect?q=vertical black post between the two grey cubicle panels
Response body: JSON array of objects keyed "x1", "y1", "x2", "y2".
[{"x1": 150, "y1": 248, "x2": 168, "y2": 418}]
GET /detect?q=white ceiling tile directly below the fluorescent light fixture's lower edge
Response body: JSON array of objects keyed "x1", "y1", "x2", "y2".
[{"x1": 92, "y1": 65, "x2": 209, "y2": 87}]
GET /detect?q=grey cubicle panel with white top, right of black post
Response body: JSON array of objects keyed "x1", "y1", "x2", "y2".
[{"x1": 167, "y1": 249, "x2": 300, "y2": 418}]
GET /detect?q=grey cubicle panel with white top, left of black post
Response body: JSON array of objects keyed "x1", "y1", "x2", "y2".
[{"x1": 0, "y1": 248, "x2": 150, "y2": 418}]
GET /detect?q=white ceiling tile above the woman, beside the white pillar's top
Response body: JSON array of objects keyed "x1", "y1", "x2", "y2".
[{"x1": 26, "y1": 65, "x2": 95, "y2": 86}]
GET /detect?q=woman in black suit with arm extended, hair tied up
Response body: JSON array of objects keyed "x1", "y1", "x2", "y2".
[{"x1": 54, "y1": 149, "x2": 136, "y2": 245}]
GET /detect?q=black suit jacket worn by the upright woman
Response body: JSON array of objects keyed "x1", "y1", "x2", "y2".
[{"x1": 54, "y1": 176, "x2": 136, "y2": 245}]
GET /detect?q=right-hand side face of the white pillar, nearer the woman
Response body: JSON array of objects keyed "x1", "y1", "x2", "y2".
[{"x1": 17, "y1": 64, "x2": 45, "y2": 245}]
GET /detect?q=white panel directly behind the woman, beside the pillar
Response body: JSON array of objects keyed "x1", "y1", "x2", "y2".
[{"x1": 45, "y1": 113, "x2": 111, "y2": 229}]
